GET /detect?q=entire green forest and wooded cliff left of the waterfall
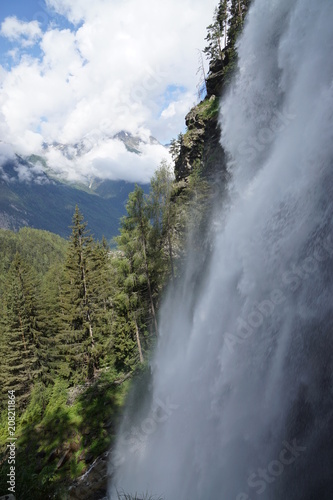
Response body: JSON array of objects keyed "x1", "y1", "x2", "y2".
[{"x1": 0, "y1": 0, "x2": 249, "y2": 500}]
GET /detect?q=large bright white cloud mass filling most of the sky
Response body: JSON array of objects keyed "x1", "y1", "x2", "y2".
[{"x1": 0, "y1": 0, "x2": 216, "y2": 181}]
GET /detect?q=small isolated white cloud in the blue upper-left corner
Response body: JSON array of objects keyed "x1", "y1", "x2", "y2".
[{"x1": 0, "y1": 16, "x2": 42, "y2": 47}]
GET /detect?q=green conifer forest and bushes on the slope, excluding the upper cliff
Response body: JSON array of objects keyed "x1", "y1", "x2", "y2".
[{"x1": 0, "y1": 188, "x2": 175, "y2": 499}]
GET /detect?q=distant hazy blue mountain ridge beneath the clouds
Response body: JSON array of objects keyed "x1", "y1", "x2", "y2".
[{"x1": 0, "y1": 150, "x2": 147, "y2": 240}]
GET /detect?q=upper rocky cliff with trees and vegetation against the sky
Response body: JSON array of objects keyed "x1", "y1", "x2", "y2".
[{"x1": 171, "y1": 0, "x2": 250, "y2": 184}]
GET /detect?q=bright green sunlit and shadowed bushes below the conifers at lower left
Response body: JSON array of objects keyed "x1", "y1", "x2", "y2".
[{"x1": 0, "y1": 370, "x2": 130, "y2": 500}]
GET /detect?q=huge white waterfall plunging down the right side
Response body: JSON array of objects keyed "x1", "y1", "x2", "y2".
[{"x1": 110, "y1": 0, "x2": 333, "y2": 500}]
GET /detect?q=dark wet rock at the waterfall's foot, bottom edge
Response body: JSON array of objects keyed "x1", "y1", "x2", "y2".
[{"x1": 69, "y1": 452, "x2": 109, "y2": 500}]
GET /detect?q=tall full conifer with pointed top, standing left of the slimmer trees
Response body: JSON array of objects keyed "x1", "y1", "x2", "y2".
[{"x1": 56, "y1": 207, "x2": 111, "y2": 381}]
